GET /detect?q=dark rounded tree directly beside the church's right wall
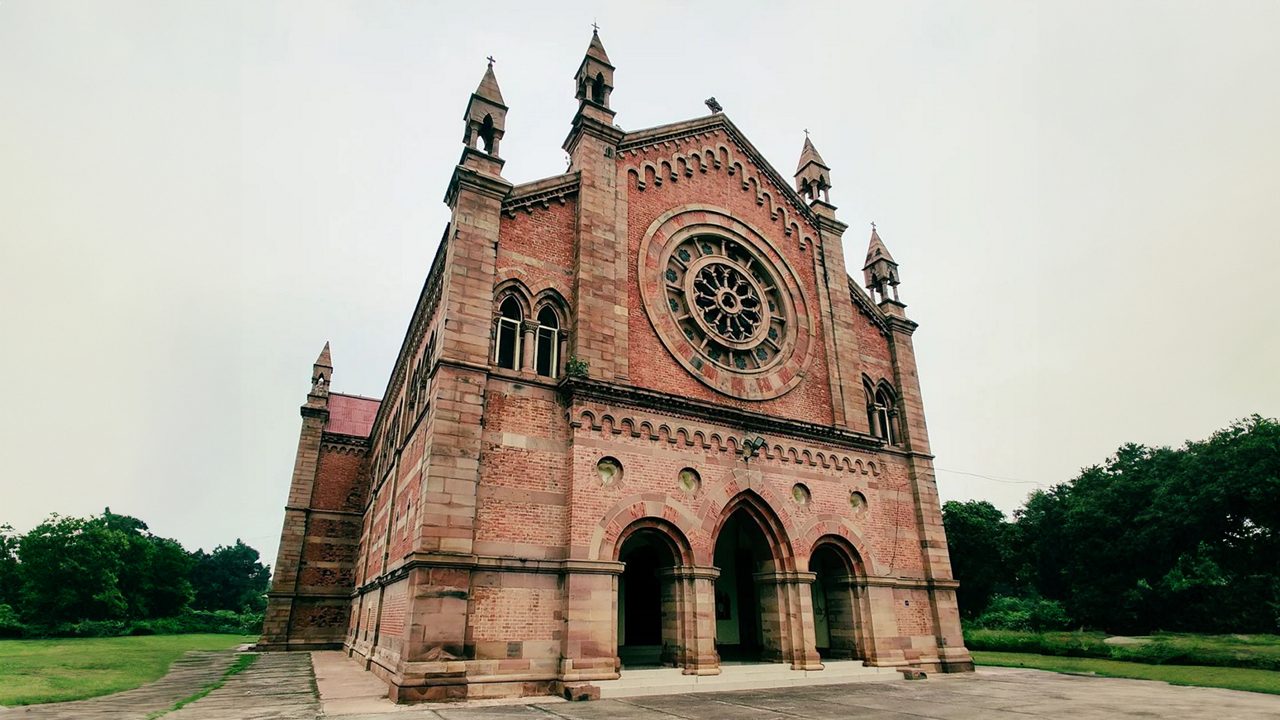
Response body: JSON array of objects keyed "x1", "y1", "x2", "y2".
[{"x1": 942, "y1": 500, "x2": 1015, "y2": 618}]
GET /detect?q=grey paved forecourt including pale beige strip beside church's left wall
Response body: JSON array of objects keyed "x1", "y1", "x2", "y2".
[{"x1": 304, "y1": 652, "x2": 1280, "y2": 720}]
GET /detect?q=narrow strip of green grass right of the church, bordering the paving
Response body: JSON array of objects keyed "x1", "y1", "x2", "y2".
[{"x1": 972, "y1": 651, "x2": 1280, "y2": 694}]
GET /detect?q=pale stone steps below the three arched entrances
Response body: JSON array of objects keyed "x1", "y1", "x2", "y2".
[{"x1": 598, "y1": 661, "x2": 902, "y2": 698}]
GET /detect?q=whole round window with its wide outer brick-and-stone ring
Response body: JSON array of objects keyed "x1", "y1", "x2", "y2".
[{"x1": 640, "y1": 208, "x2": 810, "y2": 400}]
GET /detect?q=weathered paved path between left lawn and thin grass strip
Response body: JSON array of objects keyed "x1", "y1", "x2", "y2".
[{"x1": 0, "y1": 650, "x2": 236, "y2": 720}]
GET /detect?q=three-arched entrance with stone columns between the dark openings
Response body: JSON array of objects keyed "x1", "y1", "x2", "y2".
[{"x1": 602, "y1": 491, "x2": 874, "y2": 674}]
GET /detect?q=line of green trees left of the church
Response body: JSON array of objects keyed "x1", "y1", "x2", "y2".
[{"x1": 0, "y1": 509, "x2": 270, "y2": 637}]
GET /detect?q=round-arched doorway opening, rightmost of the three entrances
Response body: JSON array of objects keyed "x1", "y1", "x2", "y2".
[{"x1": 809, "y1": 542, "x2": 861, "y2": 660}]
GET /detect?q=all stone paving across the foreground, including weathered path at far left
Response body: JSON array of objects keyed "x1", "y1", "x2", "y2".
[{"x1": 0, "y1": 652, "x2": 1280, "y2": 720}]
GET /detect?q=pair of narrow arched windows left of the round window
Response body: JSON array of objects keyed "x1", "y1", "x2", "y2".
[{"x1": 490, "y1": 282, "x2": 567, "y2": 378}]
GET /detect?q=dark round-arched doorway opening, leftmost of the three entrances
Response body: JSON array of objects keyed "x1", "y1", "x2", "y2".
[{"x1": 618, "y1": 527, "x2": 681, "y2": 669}]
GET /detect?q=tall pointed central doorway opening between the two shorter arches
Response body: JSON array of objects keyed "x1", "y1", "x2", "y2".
[{"x1": 713, "y1": 507, "x2": 781, "y2": 662}]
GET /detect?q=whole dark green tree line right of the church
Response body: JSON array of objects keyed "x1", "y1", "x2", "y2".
[{"x1": 942, "y1": 415, "x2": 1280, "y2": 634}]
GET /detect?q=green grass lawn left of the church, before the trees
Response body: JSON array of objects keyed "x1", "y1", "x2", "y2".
[{"x1": 0, "y1": 634, "x2": 256, "y2": 705}]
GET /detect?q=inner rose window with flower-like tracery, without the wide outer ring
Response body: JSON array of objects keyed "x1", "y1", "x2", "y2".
[{"x1": 664, "y1": 236, "x2": 787, "y2": 373}]
